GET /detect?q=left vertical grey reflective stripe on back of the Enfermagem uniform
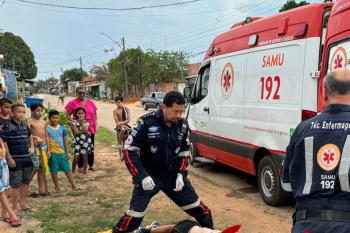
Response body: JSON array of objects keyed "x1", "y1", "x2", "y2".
[{"x1": 303, "y1": 137, "x2": 314, "y2": 194}]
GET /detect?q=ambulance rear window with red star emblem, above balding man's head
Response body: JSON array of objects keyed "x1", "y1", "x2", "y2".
[{"x1": 327, "y1": 39, "x2": 350, "y2": 73}]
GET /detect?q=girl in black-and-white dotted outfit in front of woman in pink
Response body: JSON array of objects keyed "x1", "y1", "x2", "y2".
[{"x1": 72, "y1": 107, "x2": 93, "y2": 178}]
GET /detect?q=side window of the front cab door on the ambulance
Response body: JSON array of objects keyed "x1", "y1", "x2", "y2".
[{"x1": 192, "y1": 66, "x2": 210, "y2": 104}]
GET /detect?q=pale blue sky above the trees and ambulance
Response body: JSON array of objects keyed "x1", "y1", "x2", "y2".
[{"x1": 0, "y1": 0, "x2": 322, "y2": 79}]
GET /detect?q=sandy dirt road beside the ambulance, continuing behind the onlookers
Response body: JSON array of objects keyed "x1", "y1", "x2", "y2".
[{"x1": 37, "y1": 93, "x2": 293, "y2": 233}]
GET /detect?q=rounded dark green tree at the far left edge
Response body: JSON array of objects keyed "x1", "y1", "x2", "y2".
[{"x1": 0, "y1": 32, "x2": 38, "y2": 80}]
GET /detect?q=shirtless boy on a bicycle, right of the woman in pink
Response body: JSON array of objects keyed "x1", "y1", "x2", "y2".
[{"x1": 113, "y1": 96, "x2": 130, "y2": 147}]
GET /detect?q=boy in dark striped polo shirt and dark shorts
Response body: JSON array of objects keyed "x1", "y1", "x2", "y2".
[{"x1": 2, "y1": 104, "x2": 34, "y2": 212}]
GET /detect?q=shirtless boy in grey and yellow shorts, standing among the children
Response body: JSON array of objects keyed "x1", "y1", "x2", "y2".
[{"x1": 29, "y1": 103, "x2": 50, "y2": 195}]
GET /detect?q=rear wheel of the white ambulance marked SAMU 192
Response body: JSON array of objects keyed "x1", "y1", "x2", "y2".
[{"x1": 257, "y1": 156, "x2": 287, "y2": 206}]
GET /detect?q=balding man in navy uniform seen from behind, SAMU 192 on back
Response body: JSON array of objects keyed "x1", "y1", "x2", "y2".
[{"x1": 282, "y1": 69, "x2": 350, "y2": 233}]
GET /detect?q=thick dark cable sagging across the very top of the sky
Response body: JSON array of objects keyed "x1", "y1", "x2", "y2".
[{"x1": 16, "y1": 0, "x2": 202, "y2": 11}]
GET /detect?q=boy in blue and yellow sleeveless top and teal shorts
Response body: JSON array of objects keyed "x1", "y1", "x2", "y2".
[{"x1": 48, "y1": 110, "x2": 77, "y2": 192}]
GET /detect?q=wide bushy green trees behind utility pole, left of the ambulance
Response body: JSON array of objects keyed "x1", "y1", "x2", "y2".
[{"x1": 106, "y1": 48, "x2": 190, "y2": 97}]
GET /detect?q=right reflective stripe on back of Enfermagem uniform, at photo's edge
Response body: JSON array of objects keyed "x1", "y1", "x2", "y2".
[{"x1": 339, "y1": 135, "x2": 350, "y2": 192}]
